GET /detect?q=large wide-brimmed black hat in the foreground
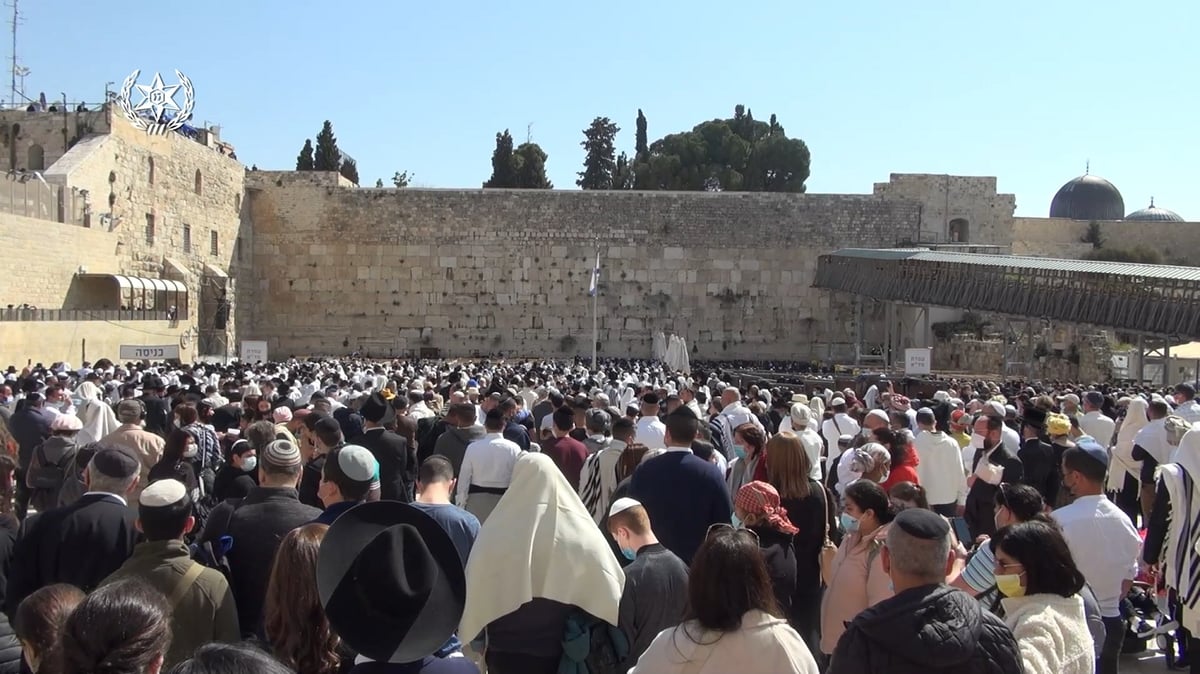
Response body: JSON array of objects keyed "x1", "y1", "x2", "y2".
[{"x1": 317, "y1": 501, "x2": 467, "y2": 662}]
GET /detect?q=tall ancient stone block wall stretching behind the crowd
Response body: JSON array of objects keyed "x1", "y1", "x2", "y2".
[{"x1": 240, "y1": 171, "x2": 917, "y2": 360}]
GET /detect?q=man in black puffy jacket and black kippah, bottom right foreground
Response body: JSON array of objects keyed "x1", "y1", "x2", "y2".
[{"x1": 828, "y1": 508, "x2": 1021, "y2": 674}]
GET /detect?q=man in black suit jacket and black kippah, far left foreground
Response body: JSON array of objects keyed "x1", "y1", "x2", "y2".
[{"x1": 5, "y1": 446, "x2": 140, "y2": 618}]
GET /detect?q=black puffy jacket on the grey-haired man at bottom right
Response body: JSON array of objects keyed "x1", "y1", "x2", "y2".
[{"x1": 828, "y1": 585, "x2": 1021, "y2": 674}]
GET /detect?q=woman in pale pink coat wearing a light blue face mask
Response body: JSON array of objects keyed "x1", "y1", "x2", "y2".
[{"x1": 821, "y1": 480, "x2": 895, "y2": 655}]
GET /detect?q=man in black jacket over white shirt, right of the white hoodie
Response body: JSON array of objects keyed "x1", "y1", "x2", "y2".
[{"x1": 962, "y1": 415, "x2": 1024, "y2": 538}]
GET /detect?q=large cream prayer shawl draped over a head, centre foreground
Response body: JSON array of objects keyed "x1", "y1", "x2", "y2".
[{"x1": 458, "y1": 453, "x2": 625, "y2": 638}]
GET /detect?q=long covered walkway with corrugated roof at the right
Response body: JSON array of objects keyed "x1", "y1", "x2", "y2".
[{"x1": 814, "y1": 248, "x2": 1200, "y2": 339}]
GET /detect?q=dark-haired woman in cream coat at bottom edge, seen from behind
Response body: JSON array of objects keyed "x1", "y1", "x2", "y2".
[{"x1": 630, "y1": 524, "x2": 817, "y2": 674}]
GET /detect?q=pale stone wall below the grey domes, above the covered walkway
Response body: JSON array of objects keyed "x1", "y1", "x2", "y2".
[{"x1": 1013, "y1": 218, "x2": 1200, "y2": 264}]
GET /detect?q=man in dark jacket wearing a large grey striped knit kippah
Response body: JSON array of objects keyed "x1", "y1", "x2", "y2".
[{"x1": 199, "y1": 440, "x2": 320, "y2": 637}]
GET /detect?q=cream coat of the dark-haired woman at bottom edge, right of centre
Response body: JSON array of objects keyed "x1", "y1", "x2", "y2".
[{"x1": 629, "y1": 610, "x2": 817, "y2": 674}]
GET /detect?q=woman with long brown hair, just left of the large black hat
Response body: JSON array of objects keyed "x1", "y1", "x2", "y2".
[{"x1": 265, "y1": 524, "x2": 354, "y2": 674}]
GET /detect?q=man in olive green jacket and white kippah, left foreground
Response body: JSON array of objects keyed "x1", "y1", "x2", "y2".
[{"x1": 101, "y1": 480, "x2": 241, "y2": 672}]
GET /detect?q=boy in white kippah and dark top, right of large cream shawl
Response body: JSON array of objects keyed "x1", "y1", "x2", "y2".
[{"x1": 608, "y1": 498, "x2": 688, "y2": 672}]
